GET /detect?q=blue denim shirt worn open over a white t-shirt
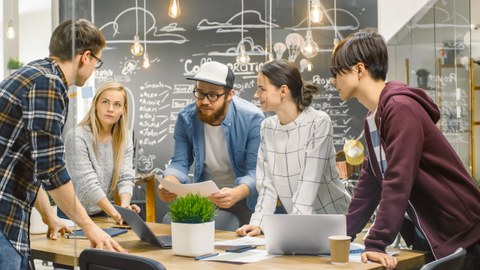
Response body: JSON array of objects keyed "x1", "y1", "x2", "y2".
[{"x1": 164, "y1": 97, "x2": 265, "y2": 211}]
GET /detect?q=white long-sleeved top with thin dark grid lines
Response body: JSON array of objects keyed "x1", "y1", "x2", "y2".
[{"x1": 250, "y1": 107, "x2": 350, "y2": 230}]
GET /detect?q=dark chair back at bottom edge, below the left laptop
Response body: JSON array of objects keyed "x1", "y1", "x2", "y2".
[{"x1": 79, "y1": 248, "x2": 166, "y2": 270}]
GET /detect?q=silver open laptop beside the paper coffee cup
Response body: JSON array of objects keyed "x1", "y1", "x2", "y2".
[{"x1": 264, "y1": 214, "x2": 347, "y2": 255}]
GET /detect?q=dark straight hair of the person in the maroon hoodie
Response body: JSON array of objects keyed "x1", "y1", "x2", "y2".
[{"x1": 331, "y1": 28, "x2": 388, "y2": 80}]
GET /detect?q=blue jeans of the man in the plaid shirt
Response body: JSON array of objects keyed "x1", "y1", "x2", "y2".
[{"x1": 0, "y1": 232, "x2": 28, "y2": 270}]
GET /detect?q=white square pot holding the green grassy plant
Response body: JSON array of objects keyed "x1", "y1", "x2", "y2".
[{"x1": 172, "y1": 221, "x2": 215, "y2": 257}]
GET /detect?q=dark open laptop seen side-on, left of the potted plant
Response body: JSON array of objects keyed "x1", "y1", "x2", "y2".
[{"x1": 114, "y1": 205, "x2": 172, "y2": 248}]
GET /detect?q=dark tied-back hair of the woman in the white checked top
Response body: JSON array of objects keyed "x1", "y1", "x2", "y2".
[{"x1": 260, "y1": 59, "x2": 319, "y2": 111}]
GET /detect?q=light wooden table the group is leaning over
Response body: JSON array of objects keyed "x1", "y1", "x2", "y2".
[{"x1": 30, "y1": 218, "x2": 424, "y2": 270}]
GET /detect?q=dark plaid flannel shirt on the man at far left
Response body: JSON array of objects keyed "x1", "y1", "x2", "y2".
[{"x1": 0, "y1": 58, "x2": 70, "y2": 255}]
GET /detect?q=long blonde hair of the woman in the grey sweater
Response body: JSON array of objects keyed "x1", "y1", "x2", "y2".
[{"x1": 78, "y1": 82, "x2": 128, "y2": 195}]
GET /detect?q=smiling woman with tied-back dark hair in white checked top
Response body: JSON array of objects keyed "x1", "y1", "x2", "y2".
[{"x1": 236, "y1": 59, "x2": 350, "y2": 236}]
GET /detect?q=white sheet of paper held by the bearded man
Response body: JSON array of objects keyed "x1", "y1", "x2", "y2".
[{"x1": 160, "y1": 178, "x2": 220, "y2": 197}]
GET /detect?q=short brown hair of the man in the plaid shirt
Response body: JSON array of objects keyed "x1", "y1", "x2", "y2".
[{"x1": 49, "y1": 19, "x2": 106, "y2": 61}]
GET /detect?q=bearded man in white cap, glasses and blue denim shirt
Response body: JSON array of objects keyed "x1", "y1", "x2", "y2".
[{"x1": 158, "y1": 61, "x2": 265, "y2": 224}]
